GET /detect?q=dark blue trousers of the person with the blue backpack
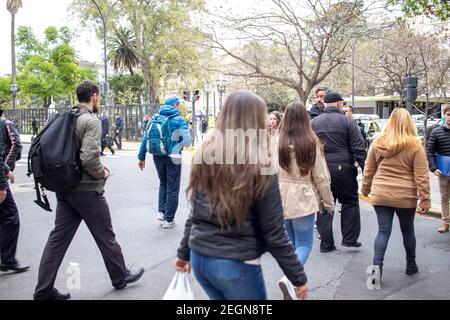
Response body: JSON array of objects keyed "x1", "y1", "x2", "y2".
[{"x1": 153, "y1": 156, "x2": 181, "y2": 222}]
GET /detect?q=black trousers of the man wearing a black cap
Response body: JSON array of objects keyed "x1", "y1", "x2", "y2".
[{"x1": 317, "y1": 163, "x2": 361, "y2": 250}]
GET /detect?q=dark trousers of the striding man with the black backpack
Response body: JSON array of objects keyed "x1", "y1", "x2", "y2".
[{"x1": 36, "y1": 192, "x2": 127, "y2": 295}]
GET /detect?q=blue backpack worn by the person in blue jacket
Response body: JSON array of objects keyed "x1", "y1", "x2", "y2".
[{"x1": 147, "y1": 114, "x2": 177, "y2": 156}]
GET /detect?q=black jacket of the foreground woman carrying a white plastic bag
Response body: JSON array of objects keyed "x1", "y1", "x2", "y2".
[{"x1": 178, "y1": 177, "x2": 307, "y2": 286}]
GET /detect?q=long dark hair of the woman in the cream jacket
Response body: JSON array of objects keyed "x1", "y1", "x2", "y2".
[{"x1": 278, "y1": 102, "x2": 320, "y2": 176}]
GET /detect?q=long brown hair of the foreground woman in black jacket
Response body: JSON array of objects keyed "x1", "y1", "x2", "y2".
[{"x1": 187, "y1": 91, "x2": 273, "y2": 227}]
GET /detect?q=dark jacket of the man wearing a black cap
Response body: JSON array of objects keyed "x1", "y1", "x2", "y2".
[{"x1": 311, "y1": 107, "x2": 367, "y2": 170}]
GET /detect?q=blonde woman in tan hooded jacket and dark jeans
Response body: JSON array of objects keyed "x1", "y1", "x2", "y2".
[{"x1": 361, "y1": 108, "x2": 431, "y2": 284}]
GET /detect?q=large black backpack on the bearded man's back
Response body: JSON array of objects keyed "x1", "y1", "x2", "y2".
[{"x1": 28, "y1": 108, "x2": 83, "y2": 211}]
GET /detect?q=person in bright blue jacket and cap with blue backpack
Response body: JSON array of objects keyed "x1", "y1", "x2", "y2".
[{"x1": 138, "y1": 96, "x2": 192, "y2": 229}]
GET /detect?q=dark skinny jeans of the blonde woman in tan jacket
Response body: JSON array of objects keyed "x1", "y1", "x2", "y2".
[{"x1": 373, "y1": 206, "x2": 416, "y2": 266}]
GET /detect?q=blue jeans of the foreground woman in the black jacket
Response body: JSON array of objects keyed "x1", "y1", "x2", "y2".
[{"x1": 191, "y1": 250, "x2": 267, "y2": 300}]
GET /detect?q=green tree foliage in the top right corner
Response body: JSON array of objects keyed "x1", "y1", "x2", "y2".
[{"x1": 387, "y1": 0, "x2": 450, "y2": 21}]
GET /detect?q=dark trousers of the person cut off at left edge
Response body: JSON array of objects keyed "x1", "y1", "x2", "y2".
[{"x1": 0, "y1": 188, "x2": 20, "y2": 264}]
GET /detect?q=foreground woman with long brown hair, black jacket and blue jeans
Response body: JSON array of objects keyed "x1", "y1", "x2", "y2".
[{"x1": 175, "y1": 91, "x2": 308, "y2": 300}]
